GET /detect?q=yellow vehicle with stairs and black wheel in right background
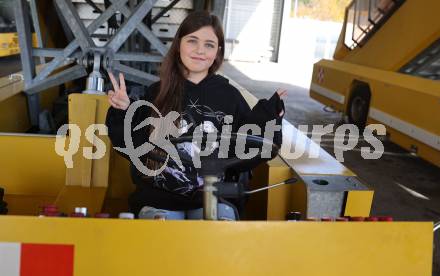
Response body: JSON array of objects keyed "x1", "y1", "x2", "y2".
[{"x1": 310, "y1": 0, "x2": 440, "y2": 166}]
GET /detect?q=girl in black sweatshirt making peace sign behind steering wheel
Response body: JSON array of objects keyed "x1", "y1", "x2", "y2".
[{"x1": 106, "y1": 12, "x2": 286, "y2": 220}]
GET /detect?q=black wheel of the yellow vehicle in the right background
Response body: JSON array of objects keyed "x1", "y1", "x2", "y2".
[{"x1": 347, "y1": 87, "x2": 371, "y2": 129}]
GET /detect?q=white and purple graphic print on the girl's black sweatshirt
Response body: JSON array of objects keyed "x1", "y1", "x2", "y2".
[{"x1": 153, "y1": 99, "x2": 226, "y2": 196}]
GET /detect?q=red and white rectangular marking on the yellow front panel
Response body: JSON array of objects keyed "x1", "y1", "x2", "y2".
[{"x1": 0, "y1": 242, "x2": 74, "y2": 276}]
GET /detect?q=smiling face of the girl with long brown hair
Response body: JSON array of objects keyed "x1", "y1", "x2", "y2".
[{"x1": 180, "y1": 26, "x2": 219, "y2": 75}]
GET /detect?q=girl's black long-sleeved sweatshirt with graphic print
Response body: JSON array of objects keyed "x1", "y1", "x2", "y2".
[{"x1": 106, "y1": 74, "x2": 284, "y2": 213}]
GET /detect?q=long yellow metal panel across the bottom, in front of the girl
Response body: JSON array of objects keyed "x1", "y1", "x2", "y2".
[{"x1": 0, "y1": 216, "x2": 433, "y2": 276}]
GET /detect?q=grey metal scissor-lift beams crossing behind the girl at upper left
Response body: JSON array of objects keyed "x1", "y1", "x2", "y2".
[{"x1": 16, "y1": 0, "x2": 168, "y2": 100}]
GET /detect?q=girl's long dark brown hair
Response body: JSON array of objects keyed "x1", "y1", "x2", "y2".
[{"x1": 154, "y1": 11, "x2": 225, "y2": 116}]
